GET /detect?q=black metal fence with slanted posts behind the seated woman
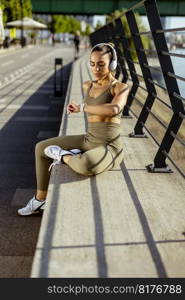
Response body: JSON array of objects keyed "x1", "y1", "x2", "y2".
[{"x1": 90, "y1": 0, "x2": 185, "y2": 178}]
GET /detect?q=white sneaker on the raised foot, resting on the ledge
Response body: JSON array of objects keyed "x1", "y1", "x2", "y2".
[{"x1": 44, "y1": 145, "x2": 82, "y2": 171}]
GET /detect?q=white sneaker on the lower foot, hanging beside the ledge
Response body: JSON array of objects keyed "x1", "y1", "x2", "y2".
[{"x1": 17, "y1": 196, "x2": 46, "y2": 216}]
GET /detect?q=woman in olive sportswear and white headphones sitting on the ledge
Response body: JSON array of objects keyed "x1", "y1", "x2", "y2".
[{"x1": 18, "y1": 43, "x2": 129, "y2": 216}]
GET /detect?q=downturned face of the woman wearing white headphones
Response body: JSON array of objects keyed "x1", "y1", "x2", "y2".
[{"x1": 90, "y1": 51, "x2": 110, "y2": 79}]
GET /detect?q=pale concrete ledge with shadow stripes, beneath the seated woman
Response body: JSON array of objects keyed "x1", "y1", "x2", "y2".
[{"x1": 31, "y1": 52, "x2": 185, "y2": 278}]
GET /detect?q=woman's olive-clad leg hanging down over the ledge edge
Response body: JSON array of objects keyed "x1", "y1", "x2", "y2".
[{"x1": 35, "y1": 135, "x2": 84, "y2": 200}]
